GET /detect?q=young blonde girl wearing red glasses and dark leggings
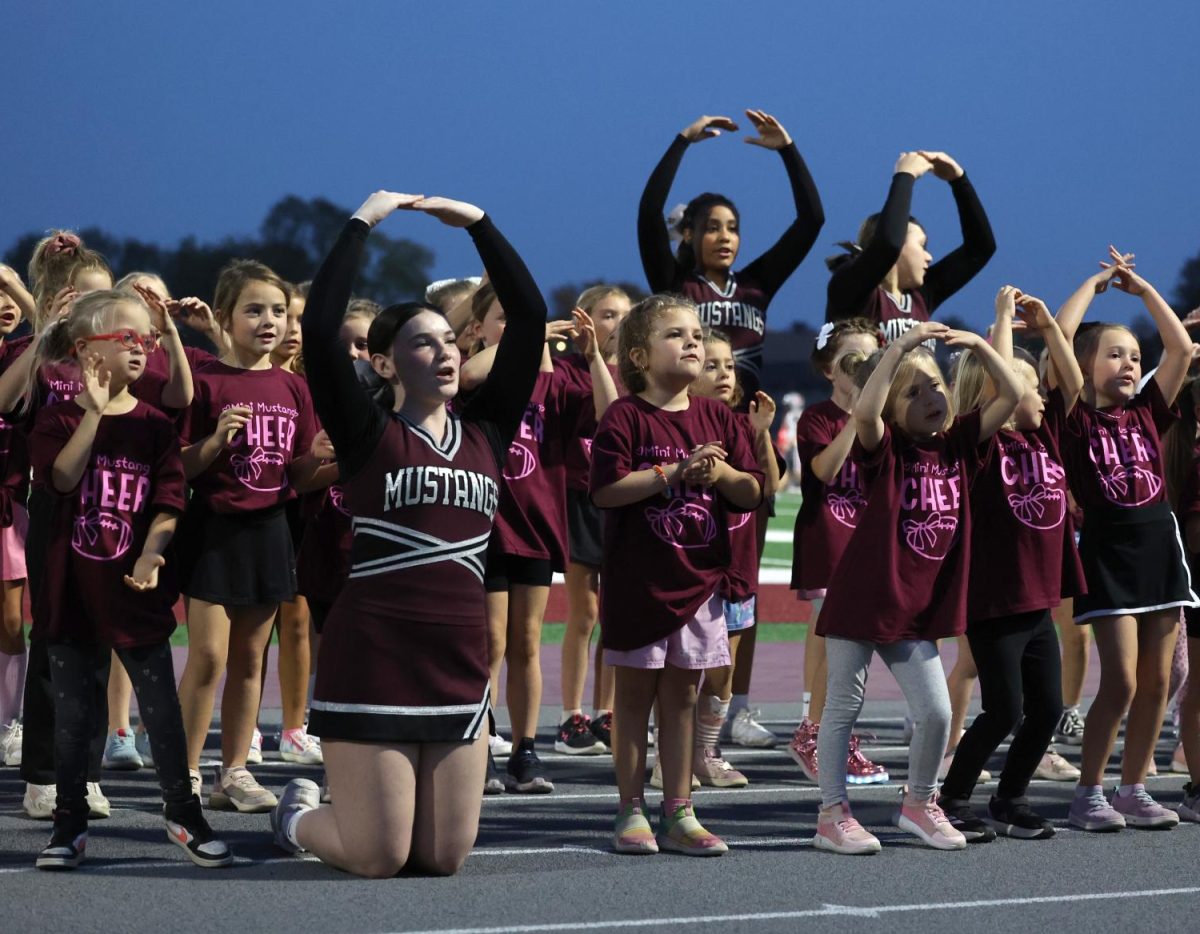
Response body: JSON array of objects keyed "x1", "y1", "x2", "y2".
[{"x1": 29, "y1": 291, "x2": 233, "y2": 869}]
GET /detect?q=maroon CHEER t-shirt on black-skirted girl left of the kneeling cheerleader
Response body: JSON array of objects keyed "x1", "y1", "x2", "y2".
[{"x1": 180, "y1": 358, "x2": 317, "y2": 514}]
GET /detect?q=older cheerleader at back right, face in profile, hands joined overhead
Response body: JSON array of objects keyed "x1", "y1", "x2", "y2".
[{"x1": 826, "y1": 150, "x2": 996, "y2": 342}]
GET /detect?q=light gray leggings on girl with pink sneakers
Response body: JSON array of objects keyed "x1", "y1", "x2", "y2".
[{"x1": 817, "y1": 636, "x2": 950, "y2": 808}]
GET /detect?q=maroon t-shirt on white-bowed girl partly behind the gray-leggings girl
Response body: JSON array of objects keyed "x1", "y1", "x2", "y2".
[{"x1": 792, "y1": 399, "x2": 866, "y2": 597}]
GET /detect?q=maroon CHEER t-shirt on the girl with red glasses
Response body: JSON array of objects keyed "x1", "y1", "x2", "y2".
[{"x1": 29, "y1": 402, "x2": 185, "y2": 647}]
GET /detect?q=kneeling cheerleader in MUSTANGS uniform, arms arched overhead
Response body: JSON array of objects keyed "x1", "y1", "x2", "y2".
[{"x1": 271, "y1": 191, "x2": 546, "y2": 878}]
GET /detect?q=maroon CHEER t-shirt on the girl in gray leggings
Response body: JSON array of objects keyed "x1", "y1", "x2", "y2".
[{"x1": 817, "y1": 411, "x2": 979, "y2": 643}]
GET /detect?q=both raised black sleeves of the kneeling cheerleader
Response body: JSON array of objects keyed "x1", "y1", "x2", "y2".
[{"x1": 301, "y1": 216, "x2": 546, "y2": 481}]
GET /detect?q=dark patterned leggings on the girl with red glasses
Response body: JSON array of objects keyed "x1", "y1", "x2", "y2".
[{"x1": 47, "y1": 642, "x2": 192, "y2": 819}]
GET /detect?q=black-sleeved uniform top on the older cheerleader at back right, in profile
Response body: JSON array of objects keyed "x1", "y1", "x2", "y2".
[{"x1": 826, "y1": 172, "x2": 996, "y2": 341}]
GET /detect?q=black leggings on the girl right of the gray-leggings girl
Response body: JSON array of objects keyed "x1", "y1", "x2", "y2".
[{"x1": 942, "y1": 610, "x2": 1062, "y2": 800}]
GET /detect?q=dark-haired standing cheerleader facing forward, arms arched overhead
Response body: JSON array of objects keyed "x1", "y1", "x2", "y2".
[{"x1": 637, "y1": 110, "x2": 824, "y2": 403}]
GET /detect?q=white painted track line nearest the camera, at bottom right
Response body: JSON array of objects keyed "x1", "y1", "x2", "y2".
[{"x1": 386, "y1": 886, "x2": 1200, "y2": 934}]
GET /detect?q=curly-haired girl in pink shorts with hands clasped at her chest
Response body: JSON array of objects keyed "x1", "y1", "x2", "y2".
[{"x1": 592, "y1": 295, "x2": 762, "y2": 856}]
